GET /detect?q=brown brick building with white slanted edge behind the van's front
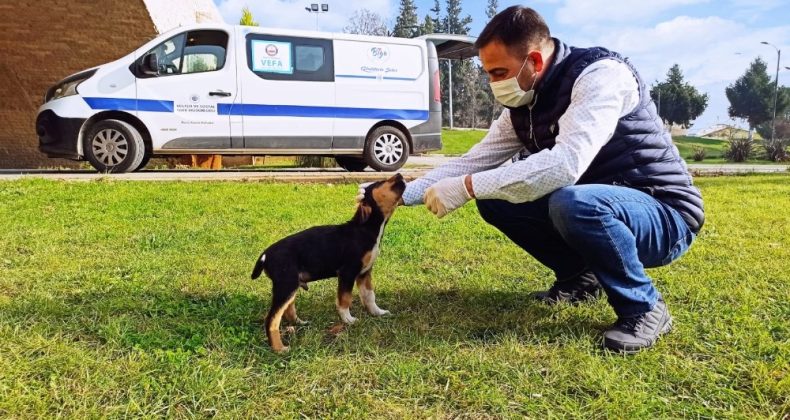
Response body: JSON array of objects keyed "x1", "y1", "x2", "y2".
[{"x1": 0, "y1": 0, "x2": 222, "y2": 168}]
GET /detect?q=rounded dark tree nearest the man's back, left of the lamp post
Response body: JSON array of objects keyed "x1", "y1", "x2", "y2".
[{"x1": 650, "y1": 64, "x2": 708, "y2": 128}]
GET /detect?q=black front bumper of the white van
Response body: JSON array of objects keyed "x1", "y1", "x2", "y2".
[{"x1": 36, "y1": 109, "x2": 87, "y2": 160}]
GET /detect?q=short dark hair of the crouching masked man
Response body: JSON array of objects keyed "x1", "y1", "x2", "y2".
[{"x1": 475, "y1": 6, "x2": 551, "y2": 55}]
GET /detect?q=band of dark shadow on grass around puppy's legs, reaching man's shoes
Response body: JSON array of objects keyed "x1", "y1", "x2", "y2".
[{"x1": 0, "y1": 280, "x2": 605, "y2": 361}]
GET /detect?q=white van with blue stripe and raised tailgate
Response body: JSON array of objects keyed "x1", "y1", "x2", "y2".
[{"x1": 36, "y1": 24, "x2": 474, "y2": 172}]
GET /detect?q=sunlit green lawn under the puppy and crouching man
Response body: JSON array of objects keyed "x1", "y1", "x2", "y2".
[{"x1": 0, "y1": 175, "x2": 790, "y2": 418}]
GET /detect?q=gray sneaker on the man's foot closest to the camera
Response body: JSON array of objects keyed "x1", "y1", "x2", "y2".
[{"x1": 603, "y1": 299, "x2": 672, "y2": 354}]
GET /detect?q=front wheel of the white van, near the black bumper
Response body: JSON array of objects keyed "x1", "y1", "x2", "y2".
[{"x1": 82, "y1": 120, "x2": 145, "y2": 173}]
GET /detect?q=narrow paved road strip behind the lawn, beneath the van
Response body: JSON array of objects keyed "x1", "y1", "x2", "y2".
[{"x1": 0, "y1": 155, "x2": 790, "y2": 183}]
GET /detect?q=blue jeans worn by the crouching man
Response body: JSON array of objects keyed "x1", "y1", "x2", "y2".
[{"x1": 477, "y1": 184, "x2": 695, "y2": 317}]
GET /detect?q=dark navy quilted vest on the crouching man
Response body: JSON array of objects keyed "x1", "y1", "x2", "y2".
[{"x1": 510, "y1": 39, "x2": 705, "y2": 232}]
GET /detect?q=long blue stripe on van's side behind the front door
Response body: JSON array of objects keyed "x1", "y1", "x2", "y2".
[{"x1": 217, "y1": 104, "x2": 428, "y2": 121}]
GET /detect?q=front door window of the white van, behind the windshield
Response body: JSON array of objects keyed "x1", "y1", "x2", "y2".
[{"x1": 135, "y1": 31, "x2": 228, "y2": 77}]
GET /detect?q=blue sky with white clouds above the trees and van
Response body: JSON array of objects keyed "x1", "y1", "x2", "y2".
[{"x1": 214, "y1": 0, "x2": 790, "y2": 133}]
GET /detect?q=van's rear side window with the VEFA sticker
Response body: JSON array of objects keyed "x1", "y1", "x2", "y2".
[{"x1": 247, "y1": 34, "x2": 335, "y2": 82}]
